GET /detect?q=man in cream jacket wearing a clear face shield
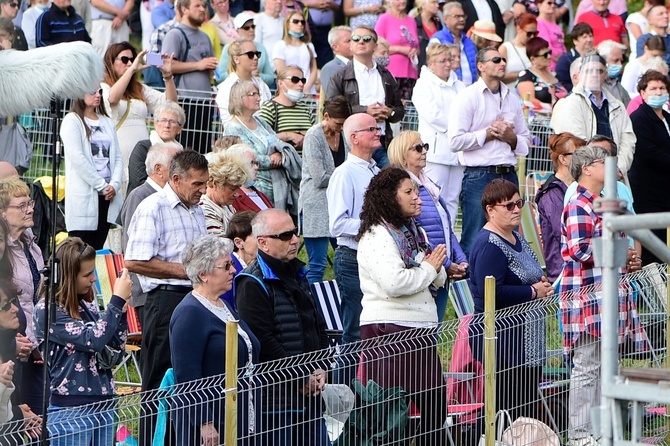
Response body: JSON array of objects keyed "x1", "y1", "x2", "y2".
[{"x1": 551, "y1": 55, "x2": 636, "y2": 183}]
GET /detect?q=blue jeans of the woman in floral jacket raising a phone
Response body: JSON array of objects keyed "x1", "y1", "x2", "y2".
[{"x1": 48, "y1": 400, "x2": 116, "y2": 446}]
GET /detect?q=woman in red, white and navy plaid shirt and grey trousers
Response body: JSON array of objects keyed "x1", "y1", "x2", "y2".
[{"x1": 558, "y1": 145, "x2": 646, "y2": 444}]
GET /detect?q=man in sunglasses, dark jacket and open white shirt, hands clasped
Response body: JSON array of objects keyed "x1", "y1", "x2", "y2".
[{"x1": 326, "y1": 26, "x2": 405, "y2": 167}]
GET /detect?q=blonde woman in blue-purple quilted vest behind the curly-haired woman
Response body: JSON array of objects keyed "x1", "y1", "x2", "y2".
[{"x1": 388, "y1": 130, "x2": 468, "y2": 322}]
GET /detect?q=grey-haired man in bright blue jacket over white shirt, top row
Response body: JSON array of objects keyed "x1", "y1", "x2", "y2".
[{"x1": 430, "y1": 2, "x2": 477, "y2": 86}]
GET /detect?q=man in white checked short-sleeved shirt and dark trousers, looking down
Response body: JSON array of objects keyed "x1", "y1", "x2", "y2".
[{"x1": 125, "y1": 150, "x2": 209, "y2": 446}]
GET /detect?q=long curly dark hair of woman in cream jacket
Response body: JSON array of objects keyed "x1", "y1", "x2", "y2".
[{"x1": 356, "y1": 166, "x2": 410, "y2": 241}]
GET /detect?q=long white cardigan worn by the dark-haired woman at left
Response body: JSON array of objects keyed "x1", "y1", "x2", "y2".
[{"x1": 60, "y1": 113, "x2": 123, "y2": 231}]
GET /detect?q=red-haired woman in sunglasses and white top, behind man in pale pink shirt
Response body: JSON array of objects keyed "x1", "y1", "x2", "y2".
[{"x1": 498, "y1": 12, "x2": 537, "y2": 91}]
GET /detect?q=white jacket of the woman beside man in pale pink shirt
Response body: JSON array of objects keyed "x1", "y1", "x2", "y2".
[{"x1": 412, "y1": 66, "x2": 465, "y2": 166}]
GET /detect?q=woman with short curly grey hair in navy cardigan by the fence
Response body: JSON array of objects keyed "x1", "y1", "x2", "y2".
[{"x1": 170, "y1": 234, "x2": 260, "y2": 446}]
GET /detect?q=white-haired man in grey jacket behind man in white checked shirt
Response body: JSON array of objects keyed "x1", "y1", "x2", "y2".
[{"x1": 119, "y1": 144, "x2": 182, "y2": 326}]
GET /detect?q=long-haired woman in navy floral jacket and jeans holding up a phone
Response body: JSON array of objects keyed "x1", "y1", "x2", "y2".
[{"x1": 34, "y1": 237, "x2": 132, "y2": 446}]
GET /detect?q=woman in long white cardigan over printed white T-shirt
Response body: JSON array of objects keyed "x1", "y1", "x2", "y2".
[{"x1": 60, "y1": 85, "x2": 123, "y2": 250}]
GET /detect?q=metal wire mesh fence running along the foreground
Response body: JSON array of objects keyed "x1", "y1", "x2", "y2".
[{"x1": 0, "y1": 265, "x2": 670, "y2": 445}]
